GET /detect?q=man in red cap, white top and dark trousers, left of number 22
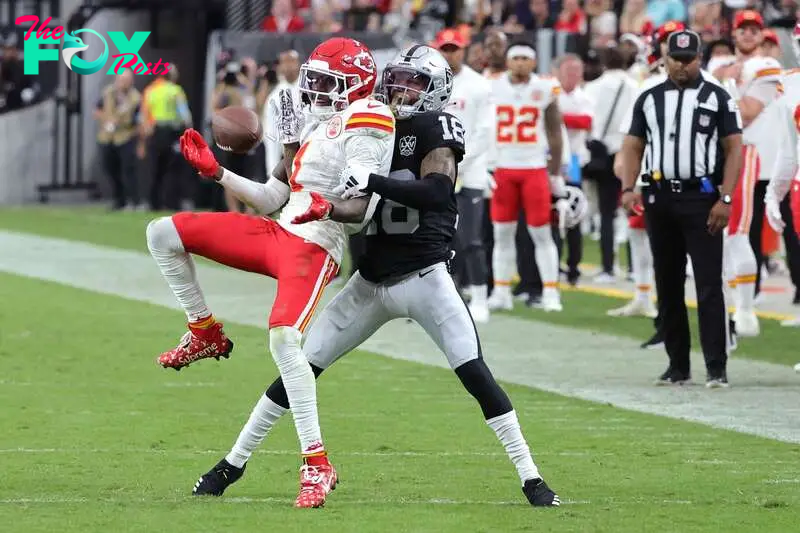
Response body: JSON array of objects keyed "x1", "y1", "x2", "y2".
[{"x1": 434, "y1": 28, "x2": 495, "y2": 322}]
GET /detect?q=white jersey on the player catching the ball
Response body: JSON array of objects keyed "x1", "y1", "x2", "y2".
[{"x1": 278, "y1": 98, "x2": 394, "y2": 264}]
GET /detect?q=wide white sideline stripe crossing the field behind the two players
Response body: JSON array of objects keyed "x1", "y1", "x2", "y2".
[{"x1": 0, "y1": 230, "x2": 800, "y2": 442}]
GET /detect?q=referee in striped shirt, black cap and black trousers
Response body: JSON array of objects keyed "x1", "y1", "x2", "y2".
[{"x1": 622, "y1": 31, "x2": 742, "y2": 388}]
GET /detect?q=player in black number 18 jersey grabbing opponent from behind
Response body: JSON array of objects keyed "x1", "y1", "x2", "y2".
[{"x1": 194, "y1": 45, "x2": 560, "y2": 506}]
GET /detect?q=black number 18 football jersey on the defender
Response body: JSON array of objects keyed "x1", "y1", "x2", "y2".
[{"x1": 358, "y1": 111, "x2": 464, "y2": 283}]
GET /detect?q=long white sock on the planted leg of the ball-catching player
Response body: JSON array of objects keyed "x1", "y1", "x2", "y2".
[{"x1": 269, "y1": 326, "x2": 324, "y2": 453}]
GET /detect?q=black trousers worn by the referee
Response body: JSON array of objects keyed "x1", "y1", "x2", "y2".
[{"x1": 643, "y1": 188, "x2": 728, "y2": 378}]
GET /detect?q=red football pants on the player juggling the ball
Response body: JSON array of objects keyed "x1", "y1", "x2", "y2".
[{"x1": 172, "y1": 213, "x2": 339, "y2": 332}]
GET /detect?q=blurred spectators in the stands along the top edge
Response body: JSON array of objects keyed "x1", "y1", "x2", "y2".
[{"x1": 261, "y1": 0, "x2": 798, "y2": 46}]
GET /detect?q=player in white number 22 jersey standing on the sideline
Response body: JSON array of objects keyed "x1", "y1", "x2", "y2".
[{"x1": 489, "y1": 44, "x2": 569, "y2": 311}]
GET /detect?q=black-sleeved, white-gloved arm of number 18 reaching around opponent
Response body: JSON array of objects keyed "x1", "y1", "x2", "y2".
[{"x1": 334, "y1": 147, "x2": 457, "y2": 211}]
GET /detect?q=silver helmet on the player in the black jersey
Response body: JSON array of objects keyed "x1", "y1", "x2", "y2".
[{"x1": 378, "y1": 44, "x2": 453, "y2": 119}]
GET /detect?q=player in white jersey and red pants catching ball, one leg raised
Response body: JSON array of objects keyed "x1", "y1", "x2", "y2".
[{"x1": 147, "y1": 37, "x2": 394, "y2": 507}]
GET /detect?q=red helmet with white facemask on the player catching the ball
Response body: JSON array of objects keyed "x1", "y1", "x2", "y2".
[{"x1": 300, "y1": 37, "x2": 377, "y2": 118}]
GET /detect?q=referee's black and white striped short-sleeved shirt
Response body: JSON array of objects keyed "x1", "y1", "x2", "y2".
[{"x1": 627, "y1": 74, "x2": 742, "y2": 184}]
